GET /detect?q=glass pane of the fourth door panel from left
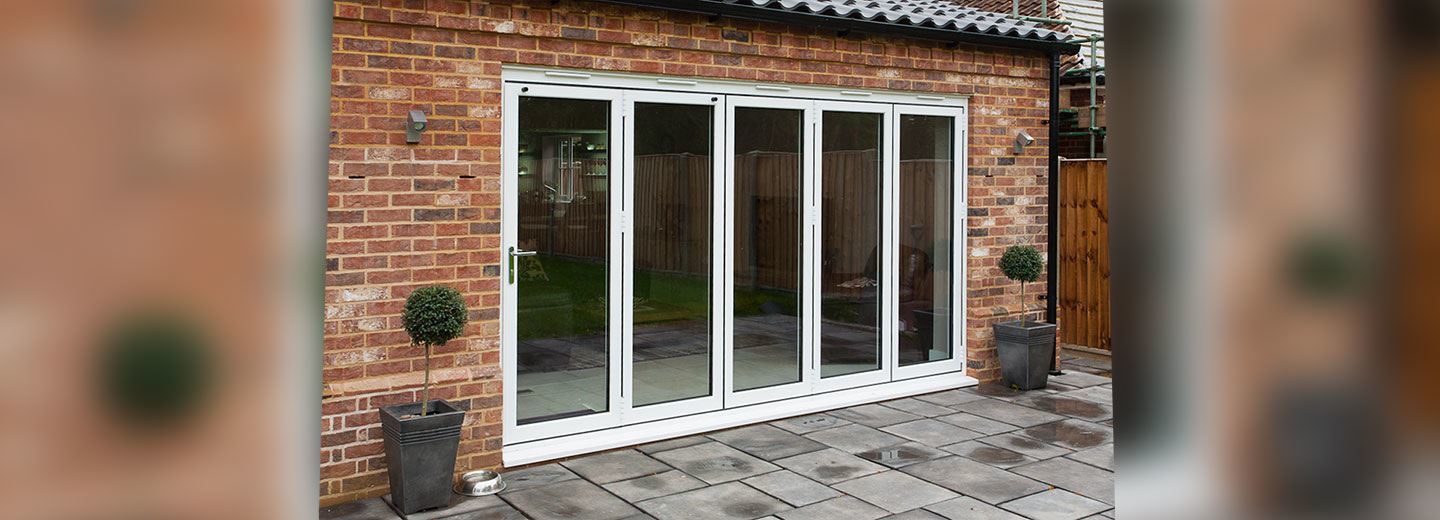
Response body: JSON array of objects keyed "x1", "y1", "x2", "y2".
[{"x1": 819, "y1": 112, "x2": 884, "y2": 377}]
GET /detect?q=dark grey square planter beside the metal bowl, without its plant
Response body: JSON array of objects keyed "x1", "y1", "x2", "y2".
[{"x1": 380, "y1": 400, "x2": 465, "y2": 514}]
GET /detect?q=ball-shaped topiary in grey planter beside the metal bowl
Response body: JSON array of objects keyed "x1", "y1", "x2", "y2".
[{"x1": 380, "y1": 287, "x2": 468, "y2": 514}]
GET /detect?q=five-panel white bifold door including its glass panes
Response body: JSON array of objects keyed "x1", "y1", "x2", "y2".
[{"x1": 501, "y1": 84, "x2": 965, "y2": 444}]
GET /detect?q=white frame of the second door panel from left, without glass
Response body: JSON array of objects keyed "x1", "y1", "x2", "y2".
[{"x1": 612, "y1": 91, "x2": 729, "y2": 423}]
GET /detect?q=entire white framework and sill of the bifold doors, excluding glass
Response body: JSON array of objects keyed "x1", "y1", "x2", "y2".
[{"x1": 501, "y1": 66, "x2": 978, "y2": 465}]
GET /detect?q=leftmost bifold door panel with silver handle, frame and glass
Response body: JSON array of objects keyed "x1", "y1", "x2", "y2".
[{"x1": 504, "y1": 86, "x2": 619, "y2": 436}]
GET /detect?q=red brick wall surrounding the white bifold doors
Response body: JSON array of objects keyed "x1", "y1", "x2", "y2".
[{"x1": 320, "y1": 0, "x2": 1048, "y2": 504}]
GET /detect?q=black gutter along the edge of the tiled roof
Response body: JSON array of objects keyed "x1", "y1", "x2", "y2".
[{"x1": 596, "y1": 0, "x2": 1080, "y2": 55}]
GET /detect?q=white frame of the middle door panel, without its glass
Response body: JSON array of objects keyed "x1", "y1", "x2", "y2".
[{"x1": 723, "y1": 95, "x2": 815, "y2": 408}]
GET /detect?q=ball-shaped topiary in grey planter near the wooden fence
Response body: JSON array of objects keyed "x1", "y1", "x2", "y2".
[{"x1": 995, "y1": 245, "x2": 1056, "y2": 390}]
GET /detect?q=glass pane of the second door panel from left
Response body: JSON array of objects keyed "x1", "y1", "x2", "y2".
[{"x1": 632, "y1": 102, "x2": 714, "y2": 406}]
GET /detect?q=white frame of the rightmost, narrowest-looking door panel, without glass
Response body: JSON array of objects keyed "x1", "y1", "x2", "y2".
[{"x1": 890, "y1": 101, "x2": 969, "y2": 380}]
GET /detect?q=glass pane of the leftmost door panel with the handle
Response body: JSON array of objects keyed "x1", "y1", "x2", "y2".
[{"x1": 516, "y1": 97, "x2": 611, "y2": 425}]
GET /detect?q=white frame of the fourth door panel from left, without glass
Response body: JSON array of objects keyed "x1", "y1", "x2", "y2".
[{"x1": 806, "y1": 101, "x2": 896, "y2": 392}]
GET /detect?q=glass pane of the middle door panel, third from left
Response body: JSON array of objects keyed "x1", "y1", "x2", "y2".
[{"x1": 732, "y1": 108, "x2": 805, "y2": 390}]
